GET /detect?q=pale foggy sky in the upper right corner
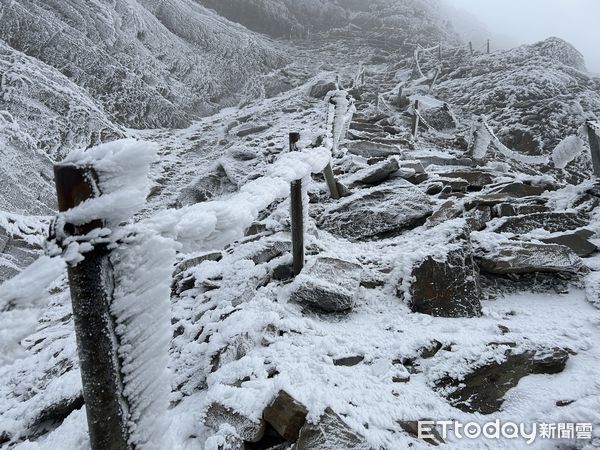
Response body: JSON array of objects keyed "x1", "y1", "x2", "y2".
[{"x1": 445, "y1": 0, "x2": 600, "y2": 73}]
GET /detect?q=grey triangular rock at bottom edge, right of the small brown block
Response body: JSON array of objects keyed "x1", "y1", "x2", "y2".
[{"x1": 292, "y1": 408, "x2": 373, "y2": 450}]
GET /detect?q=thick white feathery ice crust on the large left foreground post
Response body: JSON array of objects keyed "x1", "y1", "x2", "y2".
[{"x1": 61, "y1": 139, "x2": 176, "y2": 449}]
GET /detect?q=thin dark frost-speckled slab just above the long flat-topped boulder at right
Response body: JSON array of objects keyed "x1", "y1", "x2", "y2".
[{"x1": 494, "y1": 212, "x2": 588, "y2": 234}]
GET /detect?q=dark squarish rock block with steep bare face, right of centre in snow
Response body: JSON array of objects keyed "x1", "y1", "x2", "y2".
[{"x1": 410, "y1": 237, "x2": 482, "y2": 317}]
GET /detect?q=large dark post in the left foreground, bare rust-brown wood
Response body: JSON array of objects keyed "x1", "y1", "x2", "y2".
[{"x1": 54, "y1": 163, "x2": 130, "y2": 450}]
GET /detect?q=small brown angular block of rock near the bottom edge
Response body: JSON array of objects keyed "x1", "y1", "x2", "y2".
[{"x1": 263, "y1": 391, "x2": 308, "y2": 442}]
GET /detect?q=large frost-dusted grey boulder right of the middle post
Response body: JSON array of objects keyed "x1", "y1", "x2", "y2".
[{"x1": 319, "y1": 183, "x2": 433, "y2": 240}]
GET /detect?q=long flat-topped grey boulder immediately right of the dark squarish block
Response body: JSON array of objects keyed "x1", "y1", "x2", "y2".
[{"x1": 479, "y1": 242, "x2": 583, "y2": 274}]
